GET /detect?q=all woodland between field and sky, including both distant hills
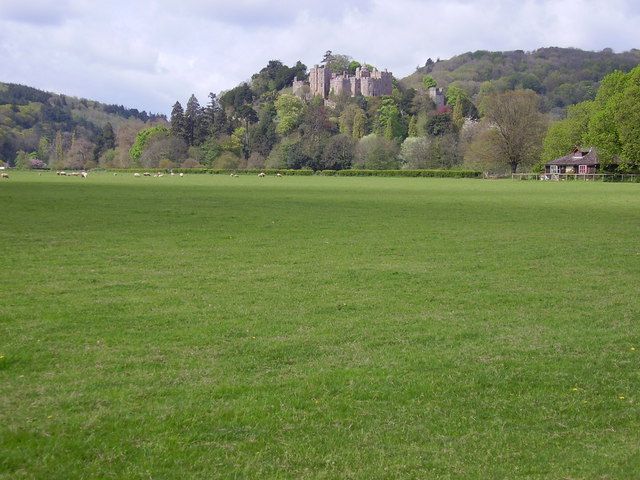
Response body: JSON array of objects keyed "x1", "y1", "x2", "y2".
[{"x1": 0, "y1": 48, "x2": 640, "y2": 172}]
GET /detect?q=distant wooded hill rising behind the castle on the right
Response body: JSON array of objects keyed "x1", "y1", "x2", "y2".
[{"x1": 401, "y1": 47, "x2": 640, "y2": 110}]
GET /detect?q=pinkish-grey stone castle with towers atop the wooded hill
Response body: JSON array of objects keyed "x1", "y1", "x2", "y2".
[{"x1": 293, "y1": 65, "x2": 393, "y2": 100}]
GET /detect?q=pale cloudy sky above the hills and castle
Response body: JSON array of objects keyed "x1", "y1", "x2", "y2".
[{"x1": 0, "y1": 0, "x2": 640, "y2": 114}]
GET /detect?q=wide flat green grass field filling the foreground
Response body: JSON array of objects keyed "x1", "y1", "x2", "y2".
[{"x1": 0, "y1": 172, "x2": 640, "y2": 480}]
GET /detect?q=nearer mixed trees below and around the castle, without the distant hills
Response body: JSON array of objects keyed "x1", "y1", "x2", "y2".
[{"x1": 4, "y1": 52, "x2": 638, "y2": 172}]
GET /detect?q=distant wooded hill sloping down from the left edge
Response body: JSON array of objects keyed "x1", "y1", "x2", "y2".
[{"x1": 0, "y1": 83, "x2": 163, "y2": 162}]
